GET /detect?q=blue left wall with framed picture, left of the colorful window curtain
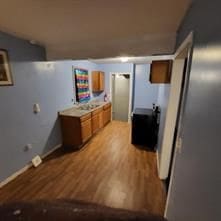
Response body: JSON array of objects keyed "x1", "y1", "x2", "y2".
[{"x1": 0, "y1": 33, "x2": 97, "y2": 181}]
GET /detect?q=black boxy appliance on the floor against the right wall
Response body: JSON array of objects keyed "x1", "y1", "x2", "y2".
[{"x1": 131, "y1": 108, "x2": 159, "y2": 151}]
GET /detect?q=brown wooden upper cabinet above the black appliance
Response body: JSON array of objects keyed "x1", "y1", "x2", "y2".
[{"x1": 150, "y1": 60, "x2": 172, "y2": 84}]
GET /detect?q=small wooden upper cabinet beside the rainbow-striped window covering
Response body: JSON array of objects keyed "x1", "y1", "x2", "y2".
[{"x1": 92, "y1": 71, "x2": 104, "y2": 92}]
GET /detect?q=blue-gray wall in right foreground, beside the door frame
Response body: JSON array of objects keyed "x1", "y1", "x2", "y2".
[{"x1": 166, "y1": 0, "x2": 221, "y2": 221}]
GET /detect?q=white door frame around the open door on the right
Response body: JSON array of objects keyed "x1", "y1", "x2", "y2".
[{"x1": 164, "y1": 32, "x2": 193, "y2": 217}]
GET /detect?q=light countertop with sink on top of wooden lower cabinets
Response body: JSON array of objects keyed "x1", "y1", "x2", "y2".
[{"x1": 59, "y1": 101, "x2": 110, "y2": 117}]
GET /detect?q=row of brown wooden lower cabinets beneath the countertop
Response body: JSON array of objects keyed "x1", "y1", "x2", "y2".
[{"x1": 60, "y1": 104, "x2": 111, "y2": 147}]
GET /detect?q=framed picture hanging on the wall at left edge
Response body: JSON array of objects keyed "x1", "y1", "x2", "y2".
[{"x1": 0, "y1": 49, "x2": 13, "y2": 86}]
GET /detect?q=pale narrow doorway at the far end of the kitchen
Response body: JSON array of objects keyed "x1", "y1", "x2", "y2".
[{"x1": 110, "y1": 73, "x2": 131, "y2": 122}]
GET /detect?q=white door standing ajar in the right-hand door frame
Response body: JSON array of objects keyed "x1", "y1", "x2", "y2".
[{"x1": 159, "y1": 40, "x2": 193, "y2": 179}]
